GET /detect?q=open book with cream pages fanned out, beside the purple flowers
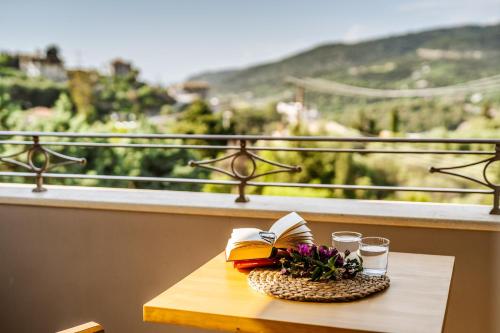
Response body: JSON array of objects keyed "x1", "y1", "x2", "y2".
[{"x1": 226, "y1": 212, "x2": 313, "y2": 261}]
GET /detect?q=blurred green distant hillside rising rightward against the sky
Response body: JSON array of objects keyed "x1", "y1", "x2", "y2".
[{"x1": 191, "y1": 24, "x2": 500, "y2": 99}]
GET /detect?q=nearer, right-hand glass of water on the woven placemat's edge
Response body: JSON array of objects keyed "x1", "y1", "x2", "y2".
[{"x1": 359, "y1": 237, "x2": 390, "y2": 276}]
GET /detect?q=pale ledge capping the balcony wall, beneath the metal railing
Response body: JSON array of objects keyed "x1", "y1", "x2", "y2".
[{"x1": 0, "y1": 184, "x2": 500, "y2": 232}]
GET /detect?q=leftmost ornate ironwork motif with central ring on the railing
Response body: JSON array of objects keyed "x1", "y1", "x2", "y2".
[{"x1": 0, "y1": 136, "x2": 86, "y2": 192}]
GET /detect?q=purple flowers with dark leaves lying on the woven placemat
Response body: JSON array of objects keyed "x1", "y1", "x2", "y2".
[{"x1": 280, "y1": 244, "x2": 363, "y2": 281}]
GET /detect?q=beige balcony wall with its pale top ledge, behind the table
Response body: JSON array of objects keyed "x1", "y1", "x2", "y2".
[{"x1": 0, "y1": 184, "x2": 500, "y2": 333}]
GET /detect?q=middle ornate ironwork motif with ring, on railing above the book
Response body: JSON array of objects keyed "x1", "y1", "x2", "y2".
[{"x1": 189, "y1": 140, "x2": 302, "y2": 202}]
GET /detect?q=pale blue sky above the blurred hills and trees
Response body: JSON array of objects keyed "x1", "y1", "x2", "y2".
[{"x1": 0, "y1": 0, "x2": 500, "y2": 84}]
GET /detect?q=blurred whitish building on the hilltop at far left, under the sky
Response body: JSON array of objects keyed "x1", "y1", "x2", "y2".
[{"x1": 19, "y1": 48, "x2": 68, "y2": 82}]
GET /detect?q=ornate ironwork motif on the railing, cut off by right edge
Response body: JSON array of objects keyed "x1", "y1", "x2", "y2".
[{"x1": 429, "y1": 143, "x2": 500, "y2": 215}]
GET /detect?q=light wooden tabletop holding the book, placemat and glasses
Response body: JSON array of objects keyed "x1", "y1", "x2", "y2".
[{"x1": 143, "y1": 252, "x2": 454, "y2": 333}]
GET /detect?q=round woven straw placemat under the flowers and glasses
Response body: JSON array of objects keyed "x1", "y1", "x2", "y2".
[{"x1": 248, "y1": 268, "x2": 390, "y2": 302}]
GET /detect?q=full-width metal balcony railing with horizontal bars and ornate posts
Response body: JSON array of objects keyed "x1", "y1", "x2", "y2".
[{"x1": 0, "y1": 131, "x2": 500, "y2": 215}]
